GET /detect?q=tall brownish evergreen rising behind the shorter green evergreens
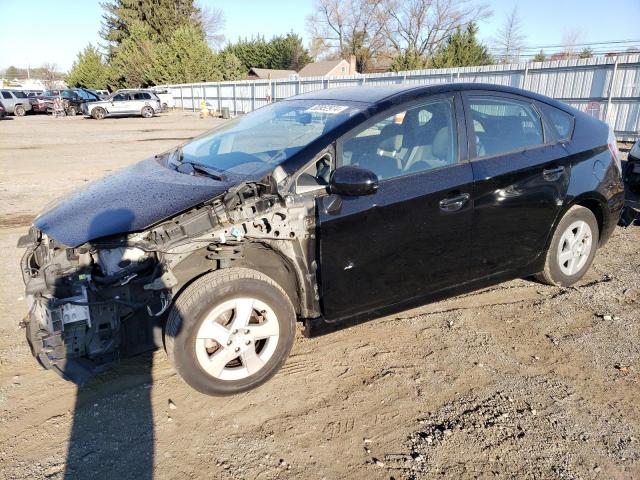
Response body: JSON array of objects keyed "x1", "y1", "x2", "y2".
[{"x1": 100, "y1": 0, "x2": 204, "y2": 47}]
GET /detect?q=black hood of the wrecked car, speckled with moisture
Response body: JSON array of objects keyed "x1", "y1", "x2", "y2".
[{"x1": 33, "y1": 158, "x2": 238, "y2": 247}]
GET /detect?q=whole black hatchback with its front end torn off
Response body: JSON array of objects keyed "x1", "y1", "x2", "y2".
[{"x1": 19, "y1": 83, "x2": 624, "y2": 395}]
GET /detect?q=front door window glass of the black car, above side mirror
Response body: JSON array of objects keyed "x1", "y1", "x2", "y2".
[{"x1": 340, "y1": 98, "x2": 458, "y2": 180}]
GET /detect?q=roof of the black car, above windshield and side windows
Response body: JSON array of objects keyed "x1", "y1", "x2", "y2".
[{"x1": 288, "y1": 83, "x2": 558, "y2": 109}]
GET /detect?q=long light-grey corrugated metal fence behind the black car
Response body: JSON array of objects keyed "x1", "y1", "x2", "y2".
[{"x1": 164, "y1": 54, "x2": 640, "y2": 140}]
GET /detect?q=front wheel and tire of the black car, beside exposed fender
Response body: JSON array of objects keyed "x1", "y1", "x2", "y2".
[{"x1": 165, "y1": 268, "x2": 296, "y2": 396}]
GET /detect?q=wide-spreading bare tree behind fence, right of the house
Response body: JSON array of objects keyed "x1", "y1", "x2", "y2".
[{"x1": 383, "y1": 0, "x2": 491, "y2": 58}]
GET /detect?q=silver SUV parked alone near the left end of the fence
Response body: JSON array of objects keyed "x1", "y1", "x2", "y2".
[{"x1": 82, "y1": 90, "x2": 162, "y2": 120}]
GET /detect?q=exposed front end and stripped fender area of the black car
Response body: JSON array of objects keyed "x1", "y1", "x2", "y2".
[{"x1": 18, "y1": 176, "x2": 320, "y2": 383}]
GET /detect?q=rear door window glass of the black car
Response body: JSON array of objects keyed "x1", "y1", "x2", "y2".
[{"x1": 469, "y1": 95, "x2": 544, "y2": 157}]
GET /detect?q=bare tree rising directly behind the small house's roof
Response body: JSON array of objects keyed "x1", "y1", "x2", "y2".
[{"x1": 307, "y1": 0, "x2": 387, "y2": 72}]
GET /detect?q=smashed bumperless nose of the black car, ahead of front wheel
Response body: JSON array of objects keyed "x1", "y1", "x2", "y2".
[{"x1": 19, "y1": 227, "x2": 171, "y2": 383}]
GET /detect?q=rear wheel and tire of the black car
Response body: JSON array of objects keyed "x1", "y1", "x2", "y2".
[{"x1": 536, "y1": 205, "x2": 600, "y2": 287}]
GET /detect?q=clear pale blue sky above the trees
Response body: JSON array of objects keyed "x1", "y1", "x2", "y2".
[{"x1": 0, "y1": 0, "x2": 640, "y2": 70}]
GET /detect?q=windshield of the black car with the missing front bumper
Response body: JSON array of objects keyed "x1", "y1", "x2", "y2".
[{"x1": 180, "y1": 100, "x2": 362, "y2": 175}]
